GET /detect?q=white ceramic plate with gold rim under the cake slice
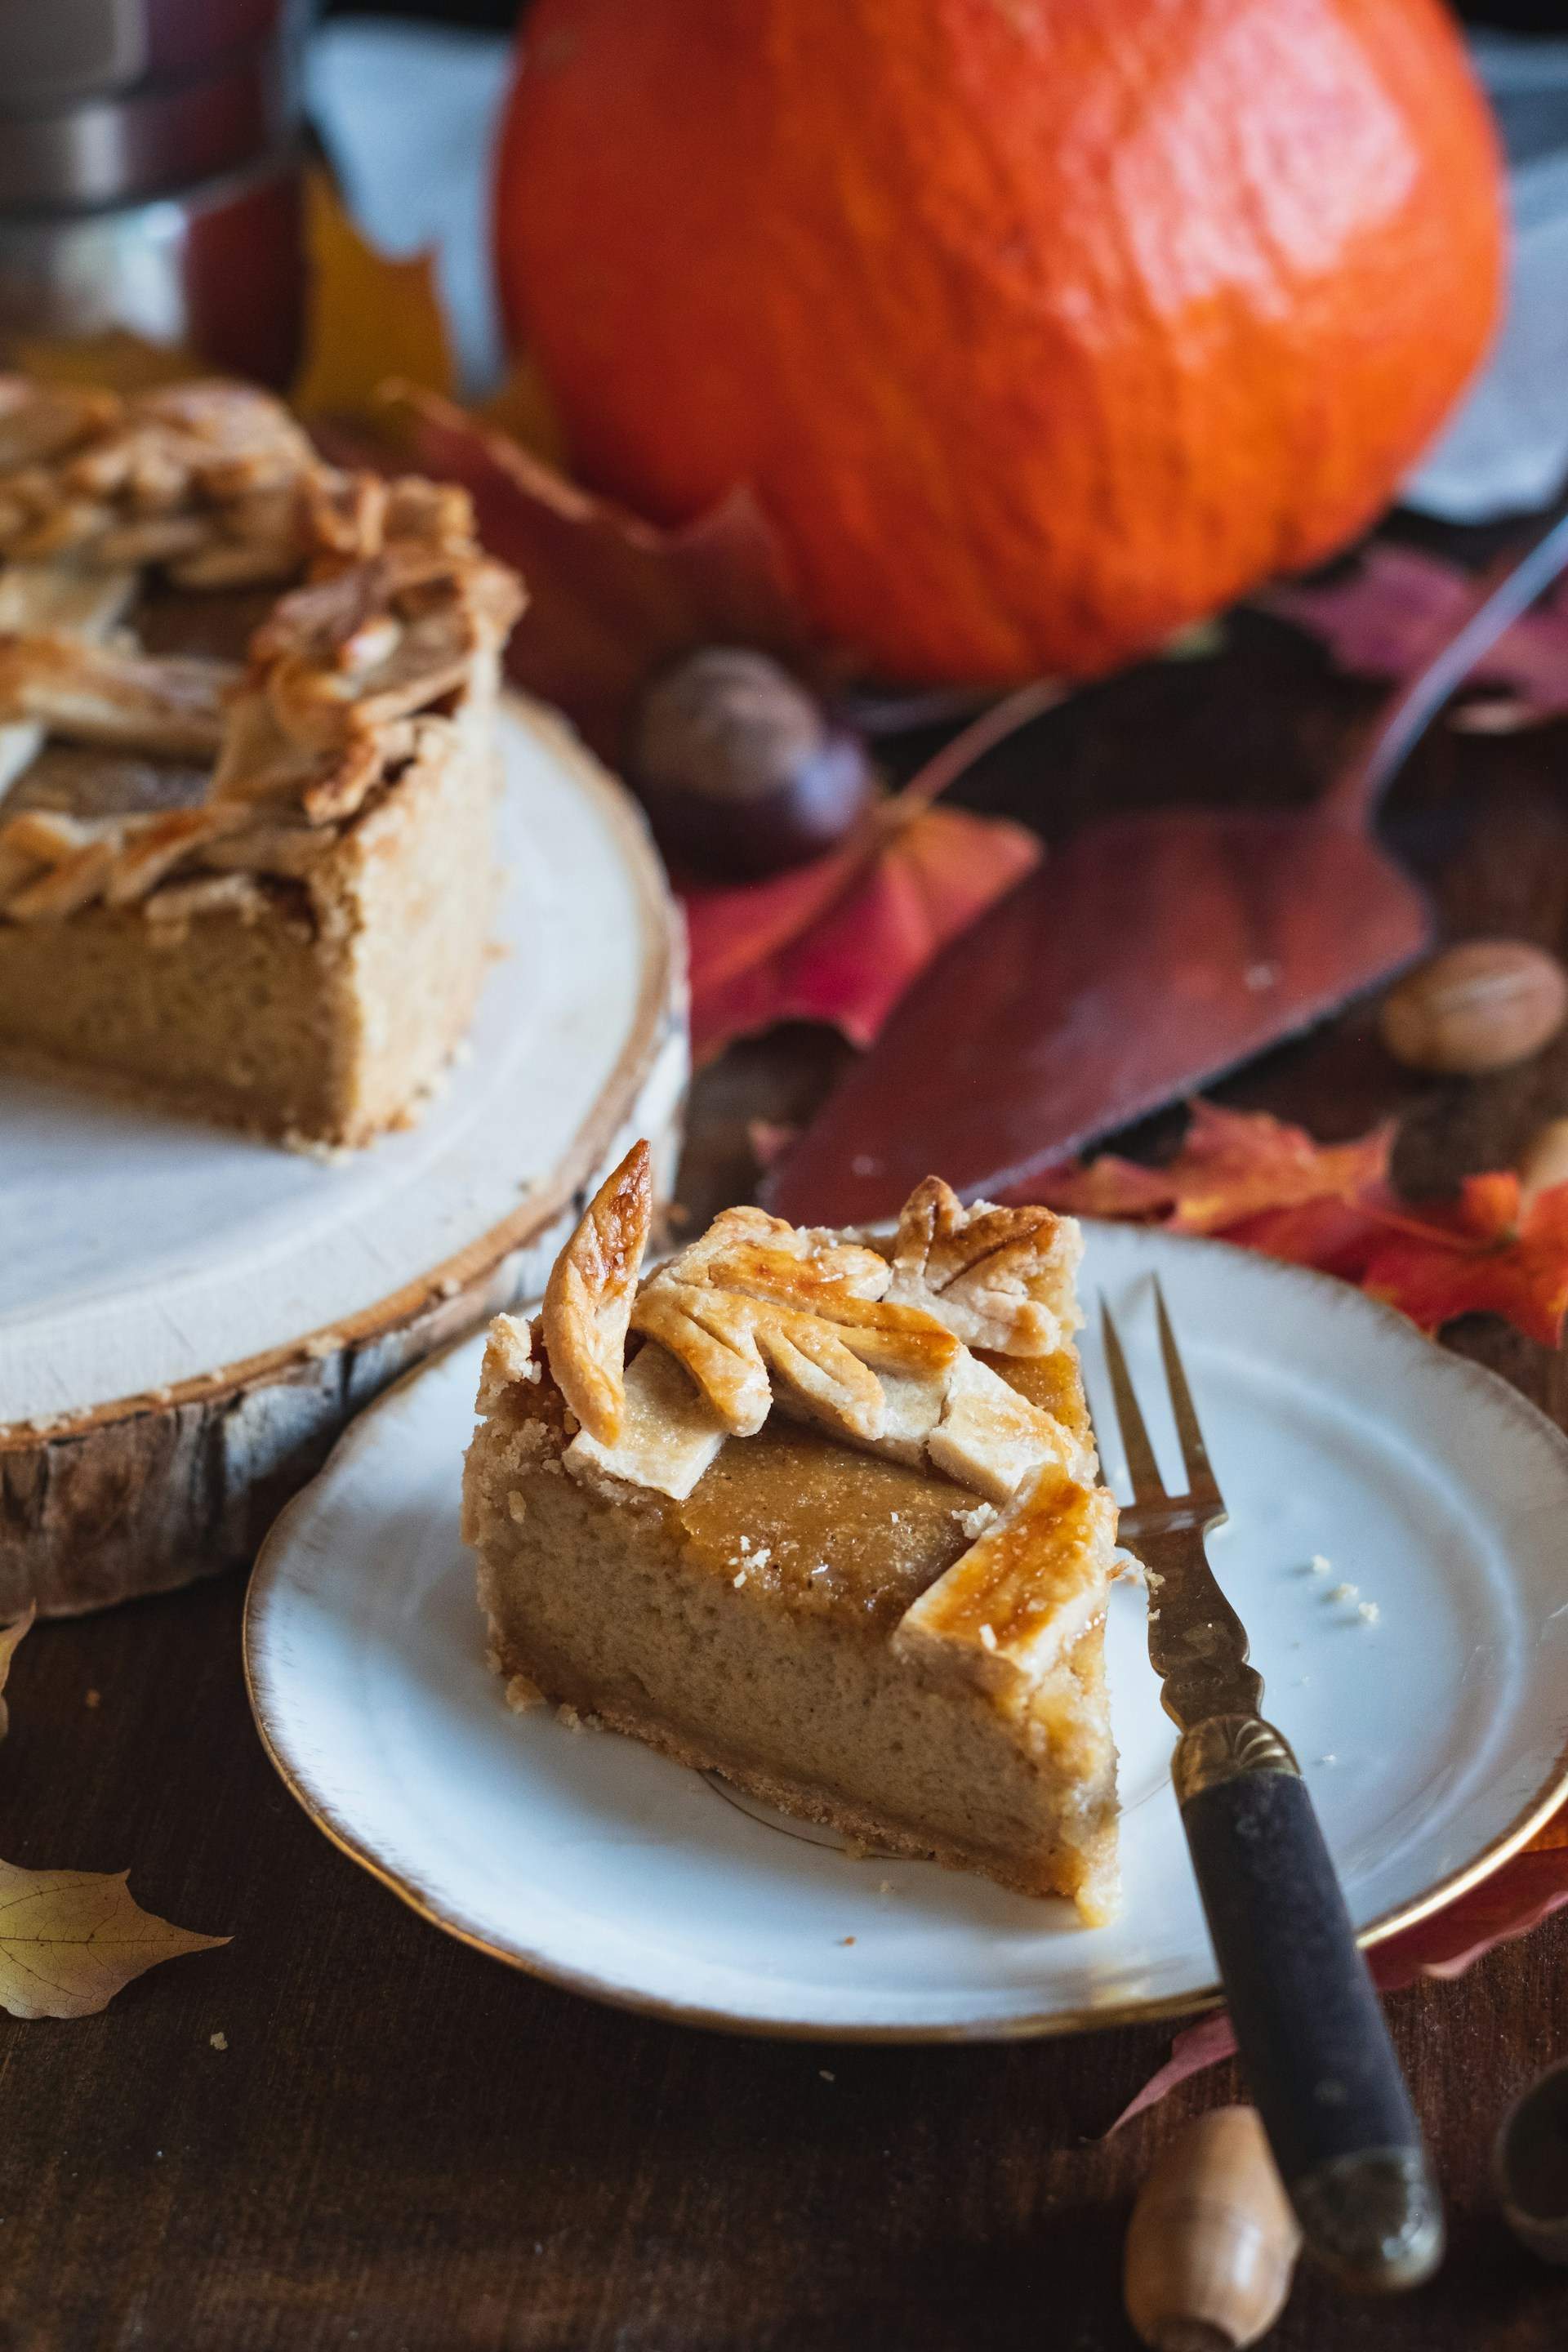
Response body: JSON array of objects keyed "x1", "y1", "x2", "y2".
[{"x1": 247, "y1": 1225, "x2": 1568, "y2": 2042}]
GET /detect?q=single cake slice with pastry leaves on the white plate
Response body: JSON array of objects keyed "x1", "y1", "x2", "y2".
[{"x1": 463, "y1": 1146, "x2": 1116, "y2": 1922}]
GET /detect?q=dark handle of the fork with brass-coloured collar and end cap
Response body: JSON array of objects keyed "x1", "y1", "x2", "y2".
[{"x1": 1175, "y1": 1717, "x2": 1443, "y2": 2293}]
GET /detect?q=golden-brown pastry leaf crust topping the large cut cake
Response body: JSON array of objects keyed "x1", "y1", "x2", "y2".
[{"x1": 0, "y1": 379, "x2": 522, "y2": 922}]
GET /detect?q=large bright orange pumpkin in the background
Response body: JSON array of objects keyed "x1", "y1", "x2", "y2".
[{"x1": 498, "y1": 0, "x2": 1502, "y2": 682}]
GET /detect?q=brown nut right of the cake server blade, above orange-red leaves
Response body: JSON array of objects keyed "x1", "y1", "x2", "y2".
[{"x1": 1380, "y1": 938, "x2": 1568, "y2": 1077}]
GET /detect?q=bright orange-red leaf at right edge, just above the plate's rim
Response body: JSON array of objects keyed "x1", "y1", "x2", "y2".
[{"x1": 1361, "y1": 1169, "x2": 1568, "y2": 1348}]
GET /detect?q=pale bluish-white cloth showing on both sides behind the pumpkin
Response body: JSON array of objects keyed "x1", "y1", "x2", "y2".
[{"x1": 310, "y1": 15, "x2": 1568, "y2": 522}]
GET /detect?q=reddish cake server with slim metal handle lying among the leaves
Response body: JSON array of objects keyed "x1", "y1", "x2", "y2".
[{"x1": 762, "y1": 506, "x2": 1568, "y2": 1223}]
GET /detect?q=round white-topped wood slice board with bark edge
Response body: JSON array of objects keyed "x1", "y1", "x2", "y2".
[{"x1": 0, "y1": 701, "x2": 687, "y2": 1620}]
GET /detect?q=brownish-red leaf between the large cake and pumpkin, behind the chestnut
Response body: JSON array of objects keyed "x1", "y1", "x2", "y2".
[{"x1": 399, "y1": 390, "x2": 808, "y2": 762}]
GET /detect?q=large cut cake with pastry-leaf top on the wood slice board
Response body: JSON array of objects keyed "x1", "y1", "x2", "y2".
[{"x1": 0, "y1": 376, "x2": 522, "y2": 1147}]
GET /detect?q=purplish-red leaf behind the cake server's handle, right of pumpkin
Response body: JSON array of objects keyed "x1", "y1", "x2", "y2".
[{"x1": 1265, "y1": 541, "x2": 1568, "y2": 717}]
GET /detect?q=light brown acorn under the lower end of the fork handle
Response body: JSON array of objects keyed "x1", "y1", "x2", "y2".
[{"x1": 1121, "y1": 2107, "x2": 1303, "y2": 2352}]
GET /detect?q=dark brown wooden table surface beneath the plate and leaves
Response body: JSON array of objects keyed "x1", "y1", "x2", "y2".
[{"x1": 0, "y1": 597, "x2": 1568, "y2": 2352}]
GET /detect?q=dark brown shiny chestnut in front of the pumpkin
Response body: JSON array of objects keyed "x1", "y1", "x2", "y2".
[{"x1": 630, "y1": 644, "x2": 877, "y2": 880}]
